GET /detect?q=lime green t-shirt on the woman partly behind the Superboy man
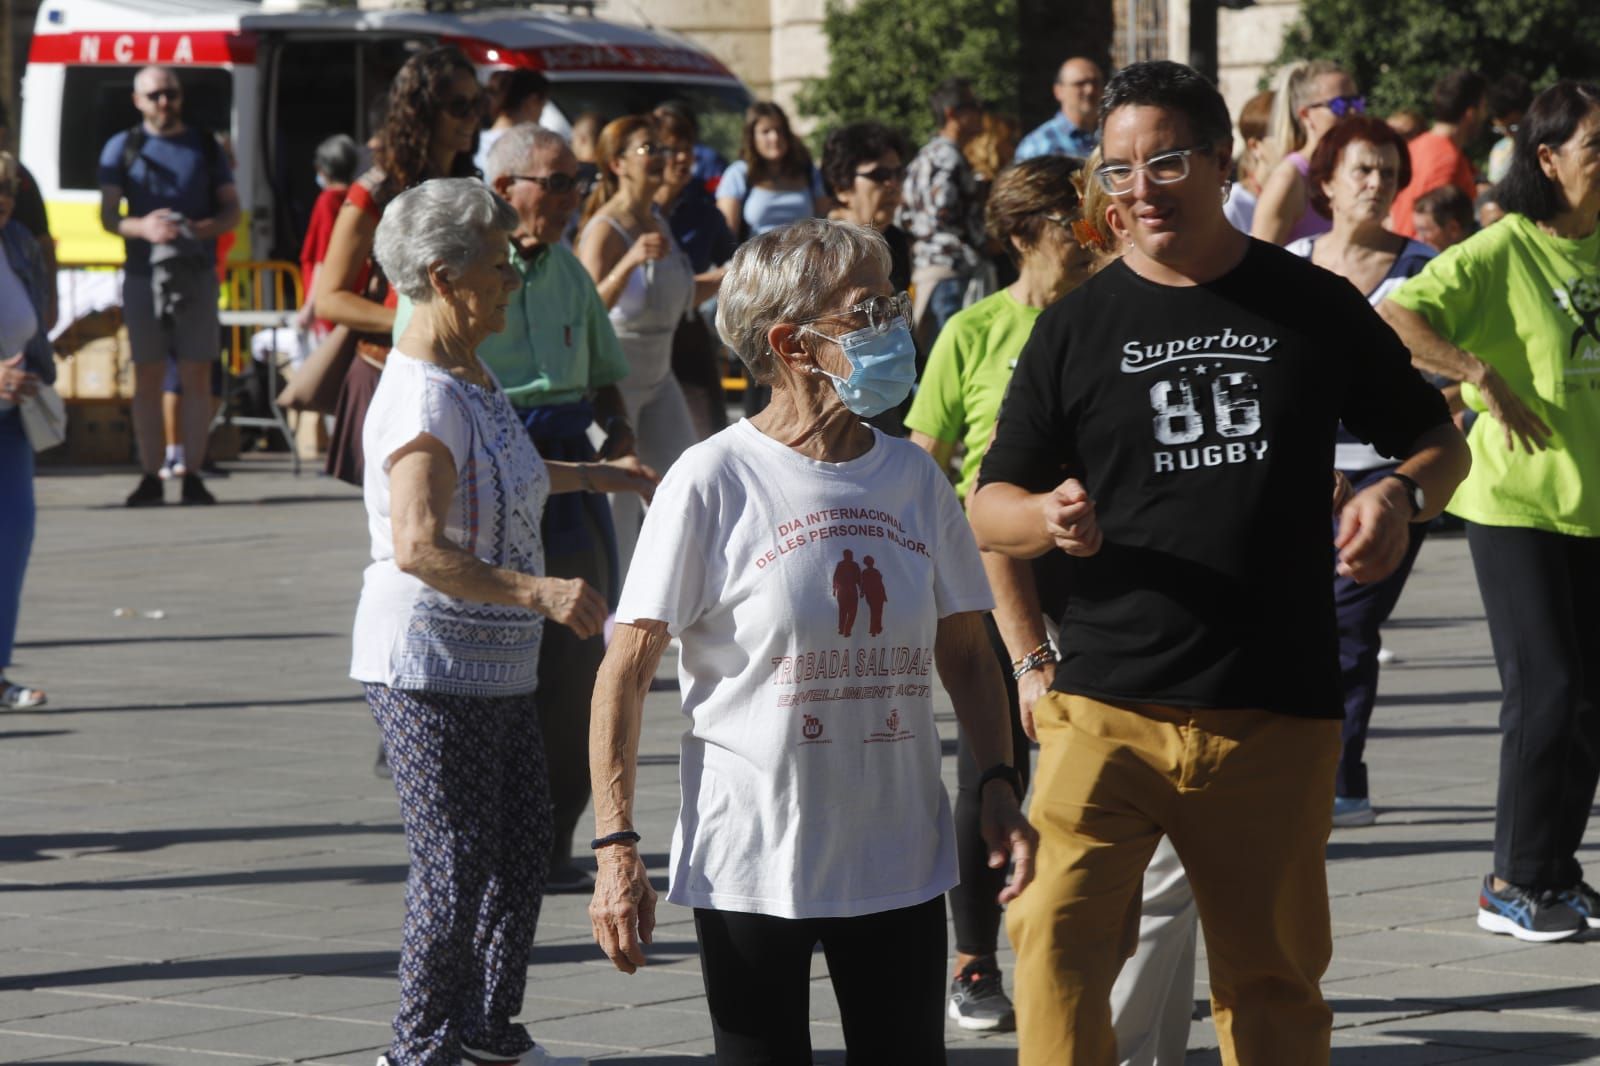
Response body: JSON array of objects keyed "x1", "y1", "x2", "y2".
[{"x1": 906, "y1": 290, "x2": 1043, "y2": 499}]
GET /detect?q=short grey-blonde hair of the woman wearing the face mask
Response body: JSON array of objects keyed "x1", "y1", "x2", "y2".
[{"x1": 717, "y1": 218, "x2": 890, "y2": 384}]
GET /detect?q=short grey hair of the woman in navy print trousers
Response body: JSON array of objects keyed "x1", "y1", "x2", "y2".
[{"x1": 373, "y1": 178, "x2": 517, "y2": 304}]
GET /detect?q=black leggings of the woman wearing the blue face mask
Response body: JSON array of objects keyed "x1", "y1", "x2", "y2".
[{"x1": 694, "y1": 896, "x2": 946, "y2": 1066}]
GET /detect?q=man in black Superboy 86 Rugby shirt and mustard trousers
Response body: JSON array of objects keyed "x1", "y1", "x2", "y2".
[{"x1": 971, "y1": 62, "x2": 1469, "y2": 1066}]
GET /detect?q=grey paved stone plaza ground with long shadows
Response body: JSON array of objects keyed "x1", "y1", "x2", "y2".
[{"x1": 0, "y1": 459, "x2": 1600, "y2": 1066}]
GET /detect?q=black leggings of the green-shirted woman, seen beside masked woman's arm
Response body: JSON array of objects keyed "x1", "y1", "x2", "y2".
[{"x1": 950, "y1": 615, "x2": 1032, "y2": 956}]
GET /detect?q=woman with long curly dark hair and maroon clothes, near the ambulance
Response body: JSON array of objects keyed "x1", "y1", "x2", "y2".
[{"x1": 310, "y1": 46, "x2": 483, "y2": 485}]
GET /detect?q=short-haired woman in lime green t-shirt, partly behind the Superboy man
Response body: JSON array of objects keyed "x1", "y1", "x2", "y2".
[{"x1": 906, "y1": 155, "x2": 1093, "y2": 1029}]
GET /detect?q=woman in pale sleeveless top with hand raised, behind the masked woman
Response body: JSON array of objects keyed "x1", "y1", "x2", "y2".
[{"x1": 578, "y1": 115, "x2": 717, "y2": 573}]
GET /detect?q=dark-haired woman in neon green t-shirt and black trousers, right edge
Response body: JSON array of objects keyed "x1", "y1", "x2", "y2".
[{"x1": 1381, "y1": 82, "x2": 1600, "y2": 943}]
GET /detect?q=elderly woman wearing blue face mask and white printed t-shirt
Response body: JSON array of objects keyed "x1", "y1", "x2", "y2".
[{"x1": 590, "y1": 219, "x2": 1035, "y2": 1064}]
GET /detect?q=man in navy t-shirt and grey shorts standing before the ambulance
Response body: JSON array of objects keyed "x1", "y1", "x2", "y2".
[{"x1": 99, "y1": 67, "x2": 238, "y2": 507}]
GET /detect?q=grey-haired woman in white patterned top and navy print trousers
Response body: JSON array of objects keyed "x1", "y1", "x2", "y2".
[{"x1": 350, "y1": 178, "x2": 653, "y2": 1066}]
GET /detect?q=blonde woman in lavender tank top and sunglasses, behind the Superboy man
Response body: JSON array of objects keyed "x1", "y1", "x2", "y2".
[{"x1": 1250, "y1": 59, "x2": 1366, "y2": 245}]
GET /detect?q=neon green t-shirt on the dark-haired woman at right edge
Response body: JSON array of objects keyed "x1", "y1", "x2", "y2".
[{"x1": 1389, "y1": 214, "x2": 1600, "y2": 536}]
